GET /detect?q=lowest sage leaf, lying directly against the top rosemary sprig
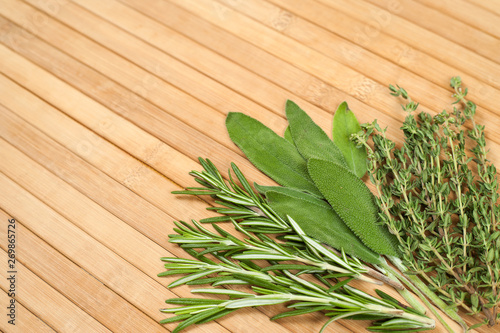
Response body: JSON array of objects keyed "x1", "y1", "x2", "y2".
[{"x1": 260, "y1": 187, "x2": 380, "y2": 264}]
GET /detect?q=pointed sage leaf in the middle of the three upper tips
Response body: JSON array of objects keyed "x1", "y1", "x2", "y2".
[{"x1": 286, "y1": 100, "x2": 347, "y2": 167}]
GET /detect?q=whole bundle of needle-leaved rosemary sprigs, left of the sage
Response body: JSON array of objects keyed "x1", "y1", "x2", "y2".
[{"x1": 159, "y1": 159, "x2": 435, "y2": 332}]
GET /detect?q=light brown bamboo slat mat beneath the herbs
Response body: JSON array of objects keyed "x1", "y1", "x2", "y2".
[{"x1": 0, "y1": 0, "x2": 500, "y2": 333}]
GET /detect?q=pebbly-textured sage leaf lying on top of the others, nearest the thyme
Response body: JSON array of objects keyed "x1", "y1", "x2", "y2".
[{"x1": 307, "y1": 158, "x2": 400, "y2": 257}]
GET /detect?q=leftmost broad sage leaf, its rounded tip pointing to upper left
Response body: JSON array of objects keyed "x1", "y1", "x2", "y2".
[{"x1": 226, "y1": 112, "x2": 321, "y2": 196}]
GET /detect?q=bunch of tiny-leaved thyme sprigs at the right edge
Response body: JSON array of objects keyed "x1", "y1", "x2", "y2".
[{"x1": 354, "y1": 77, "x2": 500, "y2": 326}]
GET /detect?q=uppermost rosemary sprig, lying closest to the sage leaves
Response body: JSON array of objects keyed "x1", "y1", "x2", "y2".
[{"x1": 173, "y1": 158, "x2": 404, "y2": 288}]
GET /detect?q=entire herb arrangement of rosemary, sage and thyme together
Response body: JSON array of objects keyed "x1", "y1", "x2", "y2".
[{"x1": 160, "y1": 78, "x2": 500, "y2": 332}]
